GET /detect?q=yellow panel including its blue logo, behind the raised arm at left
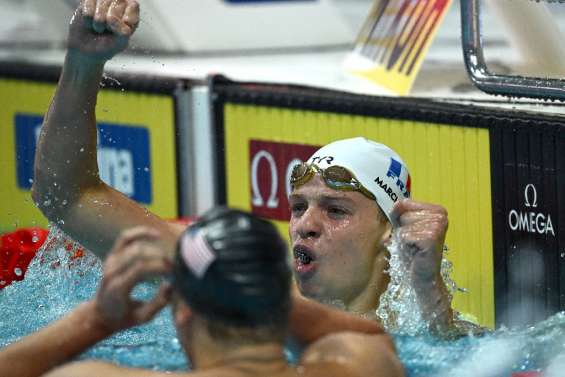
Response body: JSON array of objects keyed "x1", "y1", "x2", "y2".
[{"x1": 0, "y1": 79, "x2": 179, "y2": 233}]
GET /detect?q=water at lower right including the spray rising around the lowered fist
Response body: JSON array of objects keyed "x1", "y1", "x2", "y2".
[{"x1": 376, "y1": 229, "x2": 565, "y2": 377}]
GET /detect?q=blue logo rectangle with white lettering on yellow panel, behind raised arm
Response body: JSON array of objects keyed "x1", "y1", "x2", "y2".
[{"x1": 15, "y1": 114, "x2": 152, "y2": 204}]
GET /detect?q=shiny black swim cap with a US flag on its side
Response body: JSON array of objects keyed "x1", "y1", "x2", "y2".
[{"x1": 174, "y1": 207, "x2": 291, "y2": 340}]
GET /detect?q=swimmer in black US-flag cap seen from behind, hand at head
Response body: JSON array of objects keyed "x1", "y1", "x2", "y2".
[{"x1": 0, "y1": 208, "x2": 404, "y2": 377}]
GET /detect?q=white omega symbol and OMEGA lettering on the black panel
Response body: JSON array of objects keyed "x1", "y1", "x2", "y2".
[{"x1": 508, "y1": 183, "x2": 555, "y2": 237}]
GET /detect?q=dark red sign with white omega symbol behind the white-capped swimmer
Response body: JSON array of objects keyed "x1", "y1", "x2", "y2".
[{"x1": 249, "y1": 140, "x2": 319, "y2": 221}]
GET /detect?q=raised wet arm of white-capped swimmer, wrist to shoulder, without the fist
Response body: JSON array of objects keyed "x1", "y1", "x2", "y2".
[{"x1": 33, "y1": 50, "x2": 180, "y2": 257}]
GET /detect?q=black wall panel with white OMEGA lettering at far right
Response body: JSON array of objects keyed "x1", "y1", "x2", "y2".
[{"x1": 492, "y1": 125, "x2": 565, "y2": 326}]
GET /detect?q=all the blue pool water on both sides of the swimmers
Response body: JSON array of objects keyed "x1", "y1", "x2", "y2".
[{"x1": 0, "y1": 225, "x2": 565, "y2": 377}]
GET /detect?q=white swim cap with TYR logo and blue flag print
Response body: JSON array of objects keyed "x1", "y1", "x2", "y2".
[{"x1": 308, "y1": 137, "x2": 410, "y2": 222}]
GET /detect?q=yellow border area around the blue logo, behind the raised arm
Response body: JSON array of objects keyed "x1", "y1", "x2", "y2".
[{"x1": 0, "y1": 79, "x2": 178, "y2": 233}]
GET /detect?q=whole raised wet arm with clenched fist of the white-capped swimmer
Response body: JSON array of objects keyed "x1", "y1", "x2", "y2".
[{"x1": 32, "y1": 0, "x2": 180, "y2": 257}]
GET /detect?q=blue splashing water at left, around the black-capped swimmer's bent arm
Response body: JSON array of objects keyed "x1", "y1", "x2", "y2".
[{"x1": 0, "y1": 226, "x2": 188, "y2": 370}]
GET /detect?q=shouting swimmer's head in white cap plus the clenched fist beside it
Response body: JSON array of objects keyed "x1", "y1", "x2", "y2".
[{"x1": 289, "y1": 137, "x2": 474, "y2": 336}]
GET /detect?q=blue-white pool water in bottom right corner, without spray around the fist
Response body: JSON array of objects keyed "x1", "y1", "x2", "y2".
[{"x1": 394, "y1": 313, "x2": 565, "y2": 377}]
